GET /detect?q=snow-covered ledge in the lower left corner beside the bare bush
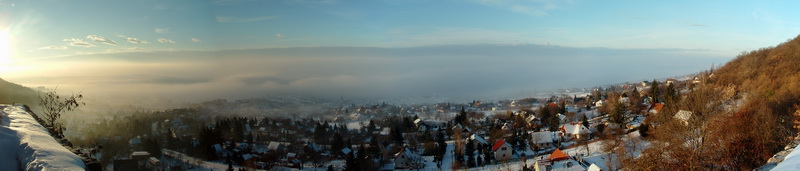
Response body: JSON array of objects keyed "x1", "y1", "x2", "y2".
[{"x1": 0, "y1": 105, "x2": 86, "y2": 170}]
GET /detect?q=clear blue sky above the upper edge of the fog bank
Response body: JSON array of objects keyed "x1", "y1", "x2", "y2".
[{"x1": 0, "y1": 0, "x2": 800, "y2": 58}]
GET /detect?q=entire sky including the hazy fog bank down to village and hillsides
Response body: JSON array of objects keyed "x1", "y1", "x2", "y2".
[{"x1": 0, "y1": 0, "x2": 800, "y2": 100}]
